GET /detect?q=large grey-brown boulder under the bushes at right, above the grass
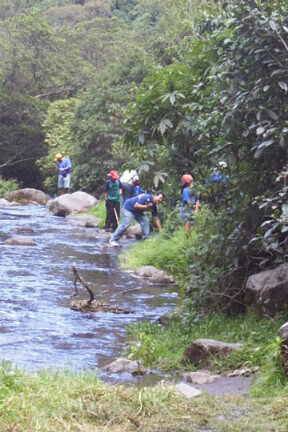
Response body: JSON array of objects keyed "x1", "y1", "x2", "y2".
[{"x1": 245, "y1": 264, "x2": 288, "y2": 315}]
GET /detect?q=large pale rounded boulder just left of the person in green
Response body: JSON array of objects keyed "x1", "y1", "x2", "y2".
[{"x1": 47, "y1": 191, "x2": 97, "y2": 217}]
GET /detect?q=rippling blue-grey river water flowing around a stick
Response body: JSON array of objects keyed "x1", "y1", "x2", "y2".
[{"x1": 0, "y1": 206, "x2": 177, "y2": 371}]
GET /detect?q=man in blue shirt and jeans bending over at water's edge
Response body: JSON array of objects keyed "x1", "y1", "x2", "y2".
[{"x1": 109, "y1": 192, "x2": 164, "y2": 246}]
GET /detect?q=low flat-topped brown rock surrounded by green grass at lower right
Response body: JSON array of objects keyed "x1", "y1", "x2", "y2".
[{"x1": 184, "y1": 339, "x2": 242, "y2": 365}]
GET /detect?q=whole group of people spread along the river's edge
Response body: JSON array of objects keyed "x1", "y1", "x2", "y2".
[{"x1": 55, "y1": 153, "x2": 228, "y2": 246}]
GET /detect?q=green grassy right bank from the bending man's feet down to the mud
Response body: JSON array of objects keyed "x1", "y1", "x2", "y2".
[{"x1": 120, "y1": 213, "x2": 288, "y2": 395}]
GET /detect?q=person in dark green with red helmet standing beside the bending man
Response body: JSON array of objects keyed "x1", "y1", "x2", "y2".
[{"x1": 105, "y1": 170, "x2": 122, "y2": 231}]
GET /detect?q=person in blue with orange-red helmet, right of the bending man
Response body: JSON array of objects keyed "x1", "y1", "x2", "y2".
[{"x1": 180, "y1": 174, "x2": 200, "y2": 232}]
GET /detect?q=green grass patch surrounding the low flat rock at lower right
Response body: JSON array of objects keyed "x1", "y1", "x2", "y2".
[{"x1": 129, "y1": 314, "x2": 285, "y2": 371}]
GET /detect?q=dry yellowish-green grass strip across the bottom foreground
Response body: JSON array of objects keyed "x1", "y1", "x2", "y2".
[{"x1": 0, "y1": 367, "x2": 288, "y2": 432}]
